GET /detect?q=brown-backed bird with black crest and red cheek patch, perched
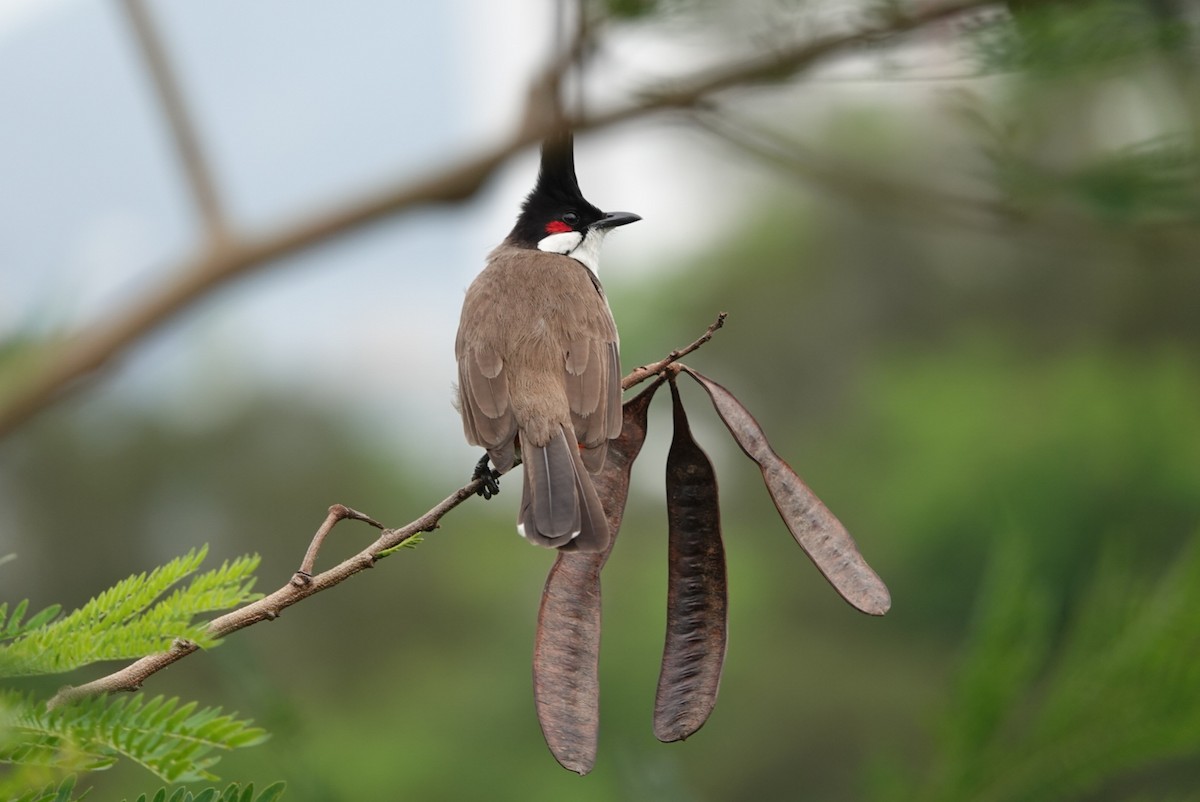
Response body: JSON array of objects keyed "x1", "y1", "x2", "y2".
[{"x1": 455, "y1": 131, "x2": 641, "y2": 552}]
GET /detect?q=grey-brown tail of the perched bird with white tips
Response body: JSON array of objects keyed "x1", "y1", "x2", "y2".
[{"x1": 517, "y1": 426, "x2": 608, "y2": 552}]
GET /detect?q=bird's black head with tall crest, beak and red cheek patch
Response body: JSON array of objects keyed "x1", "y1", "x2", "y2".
[{"x1": 508, "y1": 131, "x2": 637, "y2": 247}]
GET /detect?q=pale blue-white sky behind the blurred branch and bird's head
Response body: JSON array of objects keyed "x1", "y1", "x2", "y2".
[{"x1": 0, "y1": 0, "x2": 758, "y2": 475}]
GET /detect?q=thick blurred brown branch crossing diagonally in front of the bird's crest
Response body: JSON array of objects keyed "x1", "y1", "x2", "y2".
[{"x1": 0, "y1": 0, "x2": 996, "y2": 436}]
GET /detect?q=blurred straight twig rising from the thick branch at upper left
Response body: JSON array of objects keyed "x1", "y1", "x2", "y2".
[{"x1": 121, "y1": 0, "x2": 228, "y2": 251}]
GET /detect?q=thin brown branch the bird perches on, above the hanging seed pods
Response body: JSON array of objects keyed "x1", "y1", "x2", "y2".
[{"x1": 47, "y1": 312, "x2": 725, "y2": 710}]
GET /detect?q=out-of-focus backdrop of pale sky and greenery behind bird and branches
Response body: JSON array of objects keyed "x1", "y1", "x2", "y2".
[{"x1": 0, "y1": 0, "x2": 1200, "y2": 801}]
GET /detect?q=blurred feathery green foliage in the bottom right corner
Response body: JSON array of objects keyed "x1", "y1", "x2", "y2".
[{"x1": 876, "y1": 532, "x2": 1200, "y2": 802}]
